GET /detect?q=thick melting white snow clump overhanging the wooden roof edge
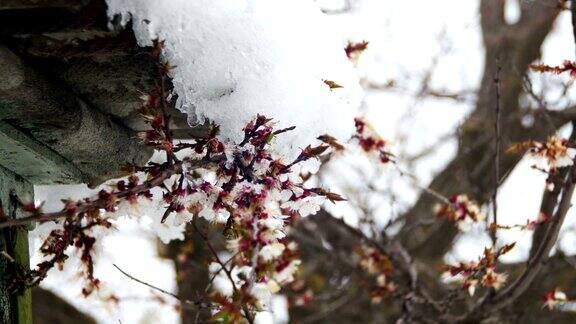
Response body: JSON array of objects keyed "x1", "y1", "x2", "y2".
[{"x1": 107, "y1": 0, "x2": 361, "y2": 159}]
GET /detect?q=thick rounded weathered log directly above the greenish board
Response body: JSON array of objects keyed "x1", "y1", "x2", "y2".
[{"x1": 0, "y1": 46, "x2": 152, "y2": 183}]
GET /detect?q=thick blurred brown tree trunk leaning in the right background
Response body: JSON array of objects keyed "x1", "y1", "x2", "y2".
[{"x1": 398, "y1": 0, "x2": 566, "y2": 262}]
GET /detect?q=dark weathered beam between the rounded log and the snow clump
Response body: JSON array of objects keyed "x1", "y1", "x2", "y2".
[{"x1": 9, "y1": 28, "x2": 200, "y2": 138}]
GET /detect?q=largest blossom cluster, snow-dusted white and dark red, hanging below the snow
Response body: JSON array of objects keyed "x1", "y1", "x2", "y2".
[{"x1": 12, "y1": 109, "x2": 343, "y2": 318}]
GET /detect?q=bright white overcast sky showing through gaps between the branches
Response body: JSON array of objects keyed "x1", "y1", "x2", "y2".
[{"x1": 32, "y1": 0, "x2": 576, "y2": 324}]
